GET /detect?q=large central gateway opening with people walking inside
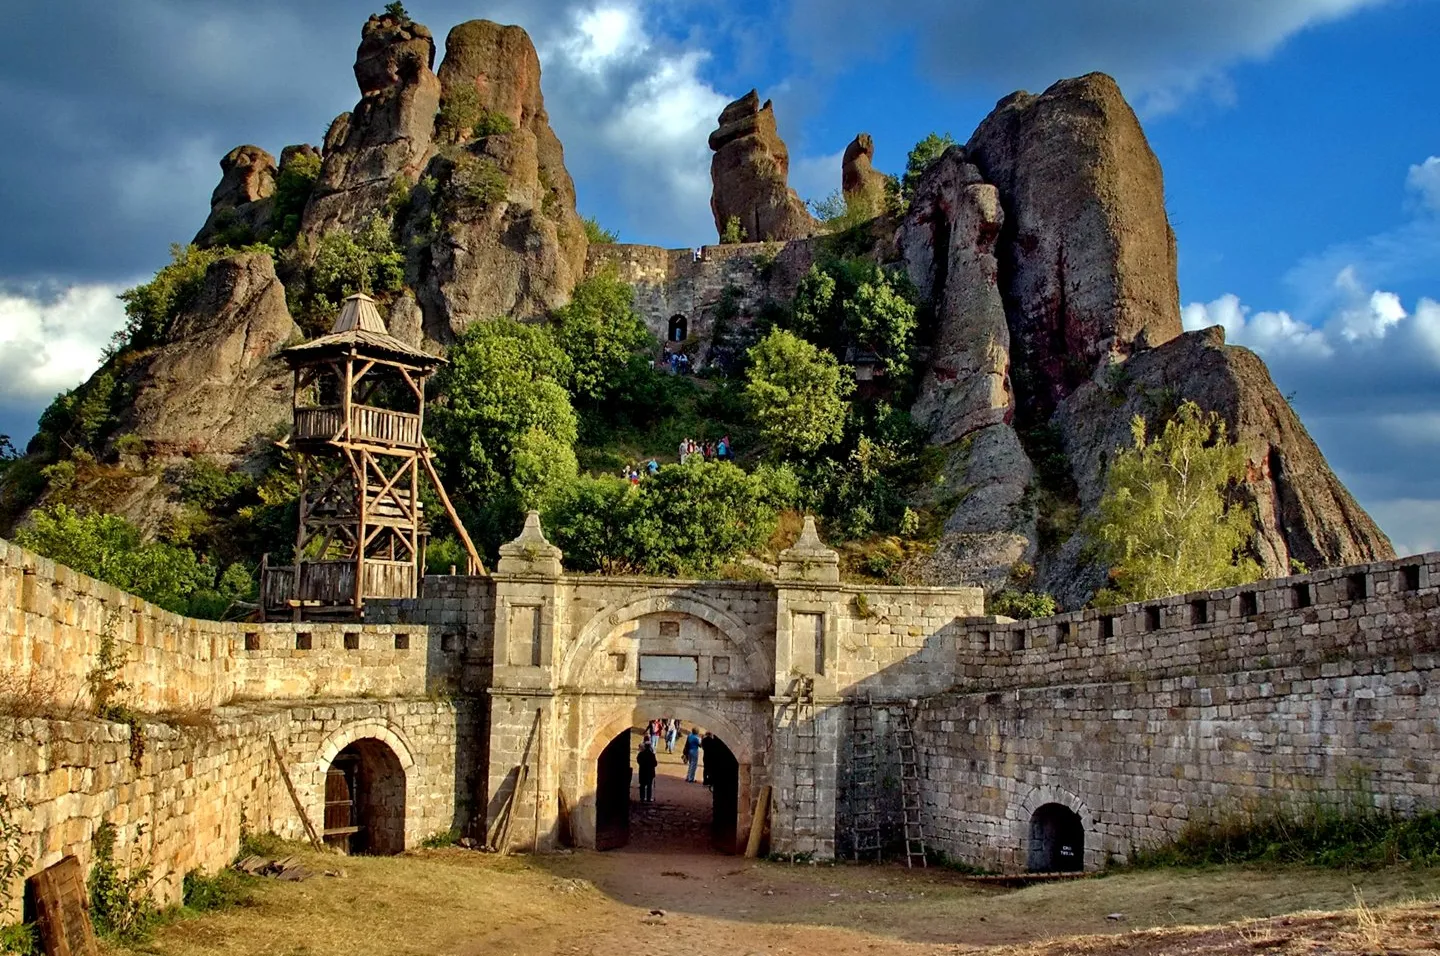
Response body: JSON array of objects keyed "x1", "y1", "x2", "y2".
[{"x1": 595, "y1": 727, "x2": 740, "y2": 854}]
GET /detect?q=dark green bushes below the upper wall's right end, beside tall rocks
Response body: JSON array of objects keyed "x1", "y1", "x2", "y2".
[{"x1": 785, "y1": 259, "x2": 919, "y2": 382}]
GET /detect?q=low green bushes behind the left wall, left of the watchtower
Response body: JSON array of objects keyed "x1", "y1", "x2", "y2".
[{"x1": 16, "y1": 504, "x2": 249, "y2": 615}]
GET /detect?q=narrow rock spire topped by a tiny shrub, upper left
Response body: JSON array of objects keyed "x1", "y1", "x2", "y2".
[{"x1": 301, "y1": 14, "x2": 441, "y2": 240}]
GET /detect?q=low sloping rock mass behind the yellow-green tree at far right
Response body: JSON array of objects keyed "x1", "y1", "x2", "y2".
[{"x1": 1043, "y1": 325, "x2": 1394, "y2": 606}]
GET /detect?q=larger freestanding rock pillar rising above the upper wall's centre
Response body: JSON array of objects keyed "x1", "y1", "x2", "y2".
[{"x1": 710, "y1": 89, "x2": 815, "y2": 242}]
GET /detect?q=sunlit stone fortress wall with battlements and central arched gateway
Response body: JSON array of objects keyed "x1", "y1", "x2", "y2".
[{"x1": 0, "y1": 521, "x2": 1440, "y2": 921}]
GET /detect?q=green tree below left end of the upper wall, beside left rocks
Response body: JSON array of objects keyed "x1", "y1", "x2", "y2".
[{"x1": 554, "y1": 272, "x2": 658, "y2": 407}]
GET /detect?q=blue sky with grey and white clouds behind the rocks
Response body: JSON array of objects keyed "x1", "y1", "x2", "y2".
[{"x1": 0, "y1": 0, "x2": 1440, "y2": 554}]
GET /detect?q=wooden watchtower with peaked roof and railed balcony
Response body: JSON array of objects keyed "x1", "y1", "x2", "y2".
[{"x1": 261, "y1": 294, "x2": 484, "y2": 619}]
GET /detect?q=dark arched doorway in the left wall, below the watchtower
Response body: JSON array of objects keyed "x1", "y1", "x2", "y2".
[{"x1": 324, "y1": 737, "x2": 405, "y2": 854}]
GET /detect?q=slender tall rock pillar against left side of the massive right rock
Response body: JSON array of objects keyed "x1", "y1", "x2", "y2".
[{"x1": 897, "y1": 148, "x2": 1035, "y2": 590}]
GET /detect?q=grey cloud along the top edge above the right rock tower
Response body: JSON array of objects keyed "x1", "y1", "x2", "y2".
[{"x1": 789, "y1": 0, "x2": 1388, "y2": 115}]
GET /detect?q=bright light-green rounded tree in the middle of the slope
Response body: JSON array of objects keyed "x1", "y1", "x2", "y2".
[{"x1": 744, "y1": 330, "x2": 855, "y2": 456}]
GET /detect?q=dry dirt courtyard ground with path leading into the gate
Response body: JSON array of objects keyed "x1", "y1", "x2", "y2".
[{"x1": 101, "y1": 754, "x2": 1440, "y2": 956}]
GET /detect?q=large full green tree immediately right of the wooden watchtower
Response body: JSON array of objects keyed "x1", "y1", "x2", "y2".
[{"x1": 432, "y1": 318, "x2": 577, "y2": 547}]
